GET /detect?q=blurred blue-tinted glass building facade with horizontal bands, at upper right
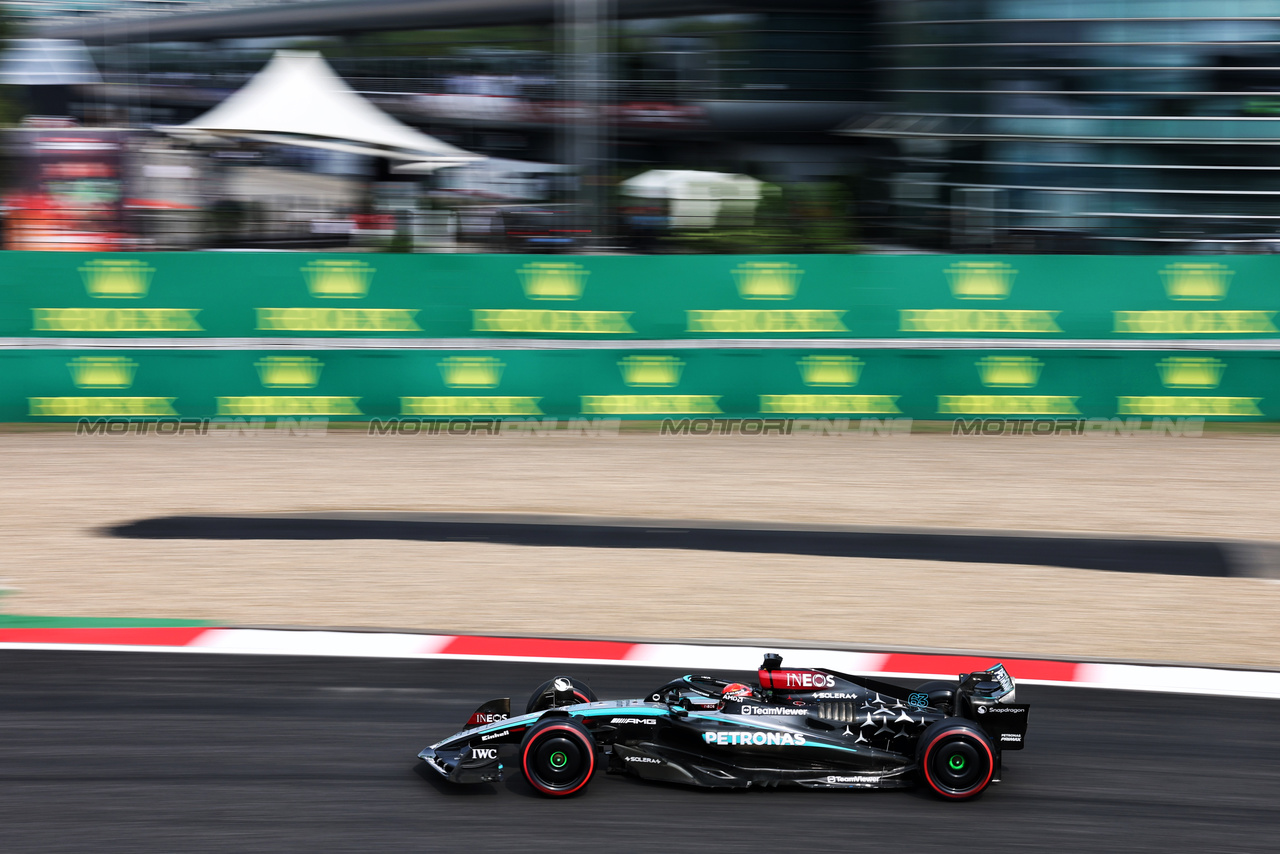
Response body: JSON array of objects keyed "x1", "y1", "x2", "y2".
[{"x1": 850, "y1": 0, "x2": 1280, "y2": 252}]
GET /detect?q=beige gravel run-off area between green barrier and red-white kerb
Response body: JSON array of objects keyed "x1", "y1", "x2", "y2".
[{"x1": 0, "y1": 431, "x2": 1280, "y2": 667}]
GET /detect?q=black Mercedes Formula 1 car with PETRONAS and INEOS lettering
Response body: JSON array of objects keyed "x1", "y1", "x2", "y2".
[{"x1": 417, "y1": 654, "x2": 1028, "y2": 800}]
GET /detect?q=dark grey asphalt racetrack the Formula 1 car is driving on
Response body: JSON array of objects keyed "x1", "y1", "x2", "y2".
[{"x1": 0, "y1": 650, "x2": 1280, "y2": 854}]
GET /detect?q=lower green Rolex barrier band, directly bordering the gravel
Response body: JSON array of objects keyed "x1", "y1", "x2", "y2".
[{"x1": 0, "y1": 348, "x2": 1280, "y2": 423}]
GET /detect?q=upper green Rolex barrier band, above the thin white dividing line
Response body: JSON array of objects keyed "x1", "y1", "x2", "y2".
[{"x1": 0, "y1": 252, "x2": 1280, "y2": 341}]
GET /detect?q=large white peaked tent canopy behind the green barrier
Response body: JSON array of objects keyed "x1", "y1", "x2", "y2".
[{"x1": 160, "y1": 50, "x2": 484, "y2": 168}]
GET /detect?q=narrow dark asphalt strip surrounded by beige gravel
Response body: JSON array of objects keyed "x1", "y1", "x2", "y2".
[{"x1": 105, "y1": 513, "x2": 1280, "y2": 577}]
